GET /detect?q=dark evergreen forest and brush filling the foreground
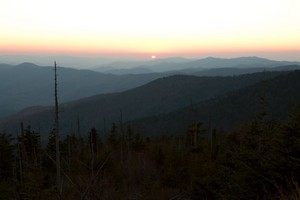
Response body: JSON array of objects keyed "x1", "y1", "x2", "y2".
[{"x1": 0, "y1": 107, "x2": 300, "y2": 200}]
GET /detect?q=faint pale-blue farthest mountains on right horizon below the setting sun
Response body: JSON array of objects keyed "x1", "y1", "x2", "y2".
[{"x1": 93, "y1": 57, "x2": 300, "y2": 75}]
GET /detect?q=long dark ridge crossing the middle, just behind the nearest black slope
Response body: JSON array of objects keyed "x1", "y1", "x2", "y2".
[{"x1": 0, "y1": 72, "x2": 286, "y2": 140}]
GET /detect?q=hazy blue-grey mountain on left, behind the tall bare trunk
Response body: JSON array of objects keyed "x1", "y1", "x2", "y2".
[{"x1": 0, "y1": 63, "x2": 164, "y2": 117}]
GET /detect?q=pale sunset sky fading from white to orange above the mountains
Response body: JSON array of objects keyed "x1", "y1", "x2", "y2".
[{"x1": 0, "y1": 0, "x2": 300, "y2": 60}]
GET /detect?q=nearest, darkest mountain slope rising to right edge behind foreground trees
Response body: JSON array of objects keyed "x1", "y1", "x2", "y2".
[{"x1": 130, "y1": 70, "x2": 300, "y2": 135}]
